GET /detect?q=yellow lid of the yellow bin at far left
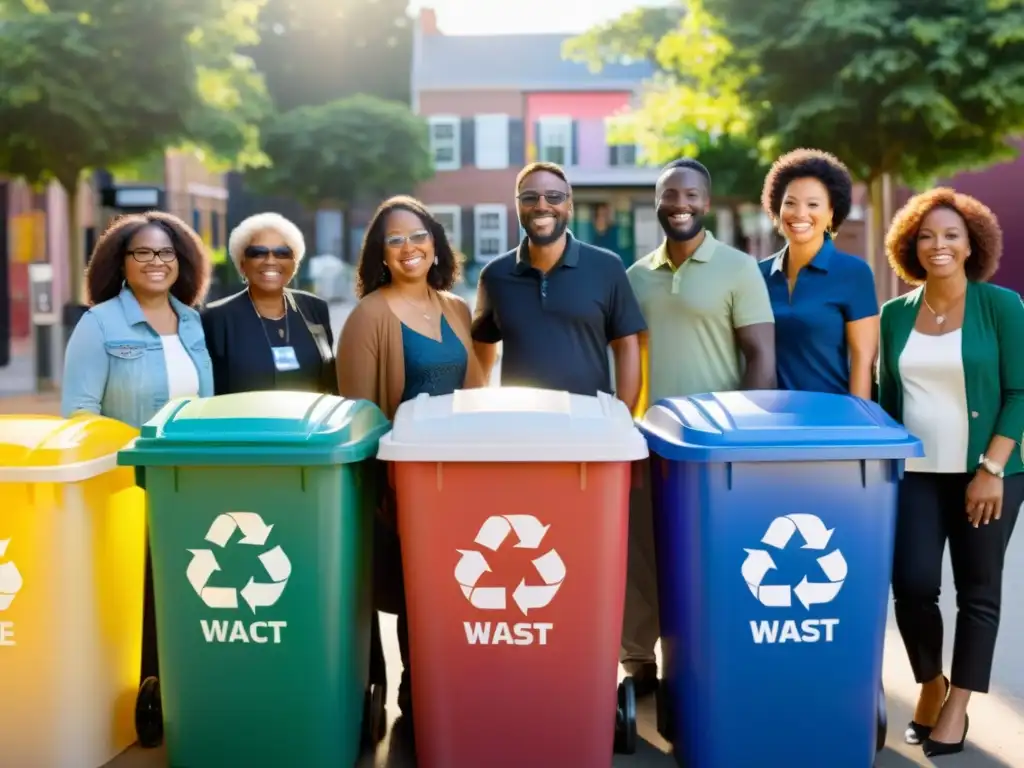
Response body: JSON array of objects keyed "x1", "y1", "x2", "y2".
[{"x1": 0, "y1": 414, "x2": 138, "y2": 482}]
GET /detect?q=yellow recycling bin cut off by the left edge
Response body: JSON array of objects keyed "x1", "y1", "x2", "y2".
[{"x1": 0, "y1": 416, "x2": 145, "y2": 768}]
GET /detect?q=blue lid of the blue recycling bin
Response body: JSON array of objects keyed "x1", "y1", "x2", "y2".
[{"x1": 640, "y1": 390, "x2": 924, "y2": 462}]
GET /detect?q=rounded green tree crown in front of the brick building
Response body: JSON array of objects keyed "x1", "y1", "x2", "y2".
[{"x1": 251, "y1": 94, "x2": 433, "y2": 208}]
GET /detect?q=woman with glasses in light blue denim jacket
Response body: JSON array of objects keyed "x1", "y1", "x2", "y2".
[{"x1": 60, "y1": 211, "x2": 213, "y2": 428}]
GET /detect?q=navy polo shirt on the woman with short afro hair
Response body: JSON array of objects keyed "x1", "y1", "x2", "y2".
[{"x1": 760, "y1": 236, "x2": 879, "y2": 394}]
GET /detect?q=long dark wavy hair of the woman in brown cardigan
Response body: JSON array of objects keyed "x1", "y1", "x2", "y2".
[{"x1": 355, "y1": 195, "x2": 460, "y2": 299}]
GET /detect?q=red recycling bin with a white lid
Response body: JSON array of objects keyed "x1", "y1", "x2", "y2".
[{"x1": 378, "y1": 388, "x2": 647, "y2": 768}]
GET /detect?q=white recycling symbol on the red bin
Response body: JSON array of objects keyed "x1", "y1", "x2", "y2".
[{"x1": 455, "y1": 515, "x2": 565, "y2": 615}]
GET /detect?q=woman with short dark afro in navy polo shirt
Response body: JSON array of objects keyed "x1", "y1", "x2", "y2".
[{"x1": 761, "y1": 150, "x2": 879, "y2": 399}]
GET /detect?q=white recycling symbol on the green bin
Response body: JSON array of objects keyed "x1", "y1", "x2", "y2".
[{"x1": 185, "y1": 512, "x2": 292, "y2": 613}]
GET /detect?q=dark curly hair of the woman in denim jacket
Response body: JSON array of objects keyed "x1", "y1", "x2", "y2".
[{"x1": 85, "y1": 211, "x2": 212, "y2": 306}]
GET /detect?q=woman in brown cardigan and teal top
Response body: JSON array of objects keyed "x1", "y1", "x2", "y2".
[{"x1": 338, "y1": 196, "x2": 483, "y2": 718}]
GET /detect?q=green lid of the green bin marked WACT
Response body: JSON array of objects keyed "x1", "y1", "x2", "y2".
[{"x1": 119, "y1": 391, "x2": 389, "y2": 467}]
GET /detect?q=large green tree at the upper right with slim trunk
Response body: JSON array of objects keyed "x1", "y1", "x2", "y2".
[{"x1": 703, "y1": 0, "x2": 1024, "y2": 255}]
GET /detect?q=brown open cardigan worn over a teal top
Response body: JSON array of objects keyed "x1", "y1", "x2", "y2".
[{"x1": 336, "y1": 291, "x2": 485, "y2": 419}]
